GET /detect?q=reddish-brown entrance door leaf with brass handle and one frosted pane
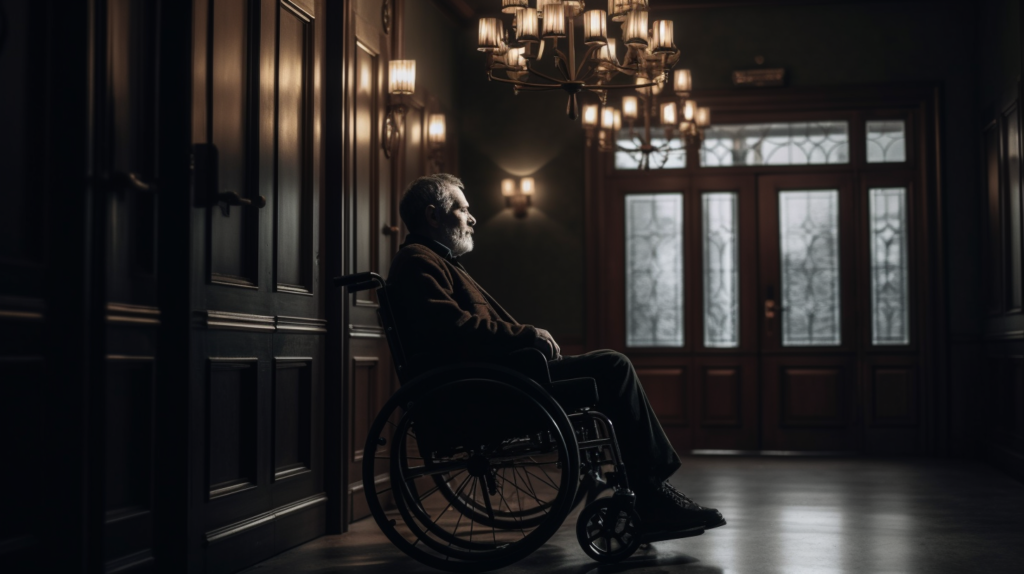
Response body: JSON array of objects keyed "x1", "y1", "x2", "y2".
[{"x1": 758, "y1": 172, "x2": 862, "y2": 451}]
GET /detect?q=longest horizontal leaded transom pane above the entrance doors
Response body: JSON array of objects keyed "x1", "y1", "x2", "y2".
[{"x1": 700, "y1": 121, "x2": 850, "y2": 168}]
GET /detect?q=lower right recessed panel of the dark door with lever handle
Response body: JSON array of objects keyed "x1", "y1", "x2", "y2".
[{"x1": 273, "y1": 359, "x2": 312, "y2": 479}]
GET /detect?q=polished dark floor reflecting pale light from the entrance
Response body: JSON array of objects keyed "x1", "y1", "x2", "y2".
[{"x1": 246, "y1": 456, "x2": 1024, "y2": 574}]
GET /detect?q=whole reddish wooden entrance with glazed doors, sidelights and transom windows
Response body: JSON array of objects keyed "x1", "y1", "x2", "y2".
[{"x1": 590, "y1": 96, "x2": 934, "y2": 452}]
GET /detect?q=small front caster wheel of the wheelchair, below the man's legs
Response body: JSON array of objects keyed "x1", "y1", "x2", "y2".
[{"x1": 577, "y1": 497, "x2": 640, "y2": 563}]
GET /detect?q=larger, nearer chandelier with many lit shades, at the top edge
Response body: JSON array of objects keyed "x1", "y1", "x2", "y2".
[{"x1": 477, "y1": 0, "x2": 679, "y2": 120}]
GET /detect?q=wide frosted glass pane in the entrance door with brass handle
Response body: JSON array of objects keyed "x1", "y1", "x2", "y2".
[{"x1": 778, "y1": 189, "x2": 842, "y2": 347}]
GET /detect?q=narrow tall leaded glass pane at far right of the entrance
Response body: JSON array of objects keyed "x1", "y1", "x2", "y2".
[{"x1": 868, "y1": 187, "x2": 910, "y2": 345}]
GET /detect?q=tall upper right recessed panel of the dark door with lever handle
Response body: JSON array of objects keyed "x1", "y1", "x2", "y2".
[{"x1": 274, "y1": 7, "x2": 312, "y2": 292}]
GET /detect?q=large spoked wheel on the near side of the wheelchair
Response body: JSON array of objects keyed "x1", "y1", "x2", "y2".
[{"x1": 362, "y1": 365, "x2": 580, "y2": 572}]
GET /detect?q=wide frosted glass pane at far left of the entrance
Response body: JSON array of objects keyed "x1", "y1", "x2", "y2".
[{"x1": 626, "y1": 193, "x2": 683, "y2": 347}]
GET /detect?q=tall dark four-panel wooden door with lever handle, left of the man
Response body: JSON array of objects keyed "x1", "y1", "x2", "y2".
[{"x1": 188, "y1": 0, "x2": 327, "y2": 572}]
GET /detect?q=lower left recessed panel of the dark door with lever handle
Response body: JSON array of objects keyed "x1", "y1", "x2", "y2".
[{"x1": 207, "y1": 359, "x2": 257, "y2": 497}]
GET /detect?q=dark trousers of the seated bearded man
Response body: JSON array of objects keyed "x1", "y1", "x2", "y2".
[{"x1": 548, "y1": 349, "x2": 681, "y2": 489}]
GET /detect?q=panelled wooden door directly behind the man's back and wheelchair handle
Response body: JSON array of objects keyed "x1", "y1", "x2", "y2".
[{"x1": 344, "y1": 0, "x2": 399, "y2": 522}]
